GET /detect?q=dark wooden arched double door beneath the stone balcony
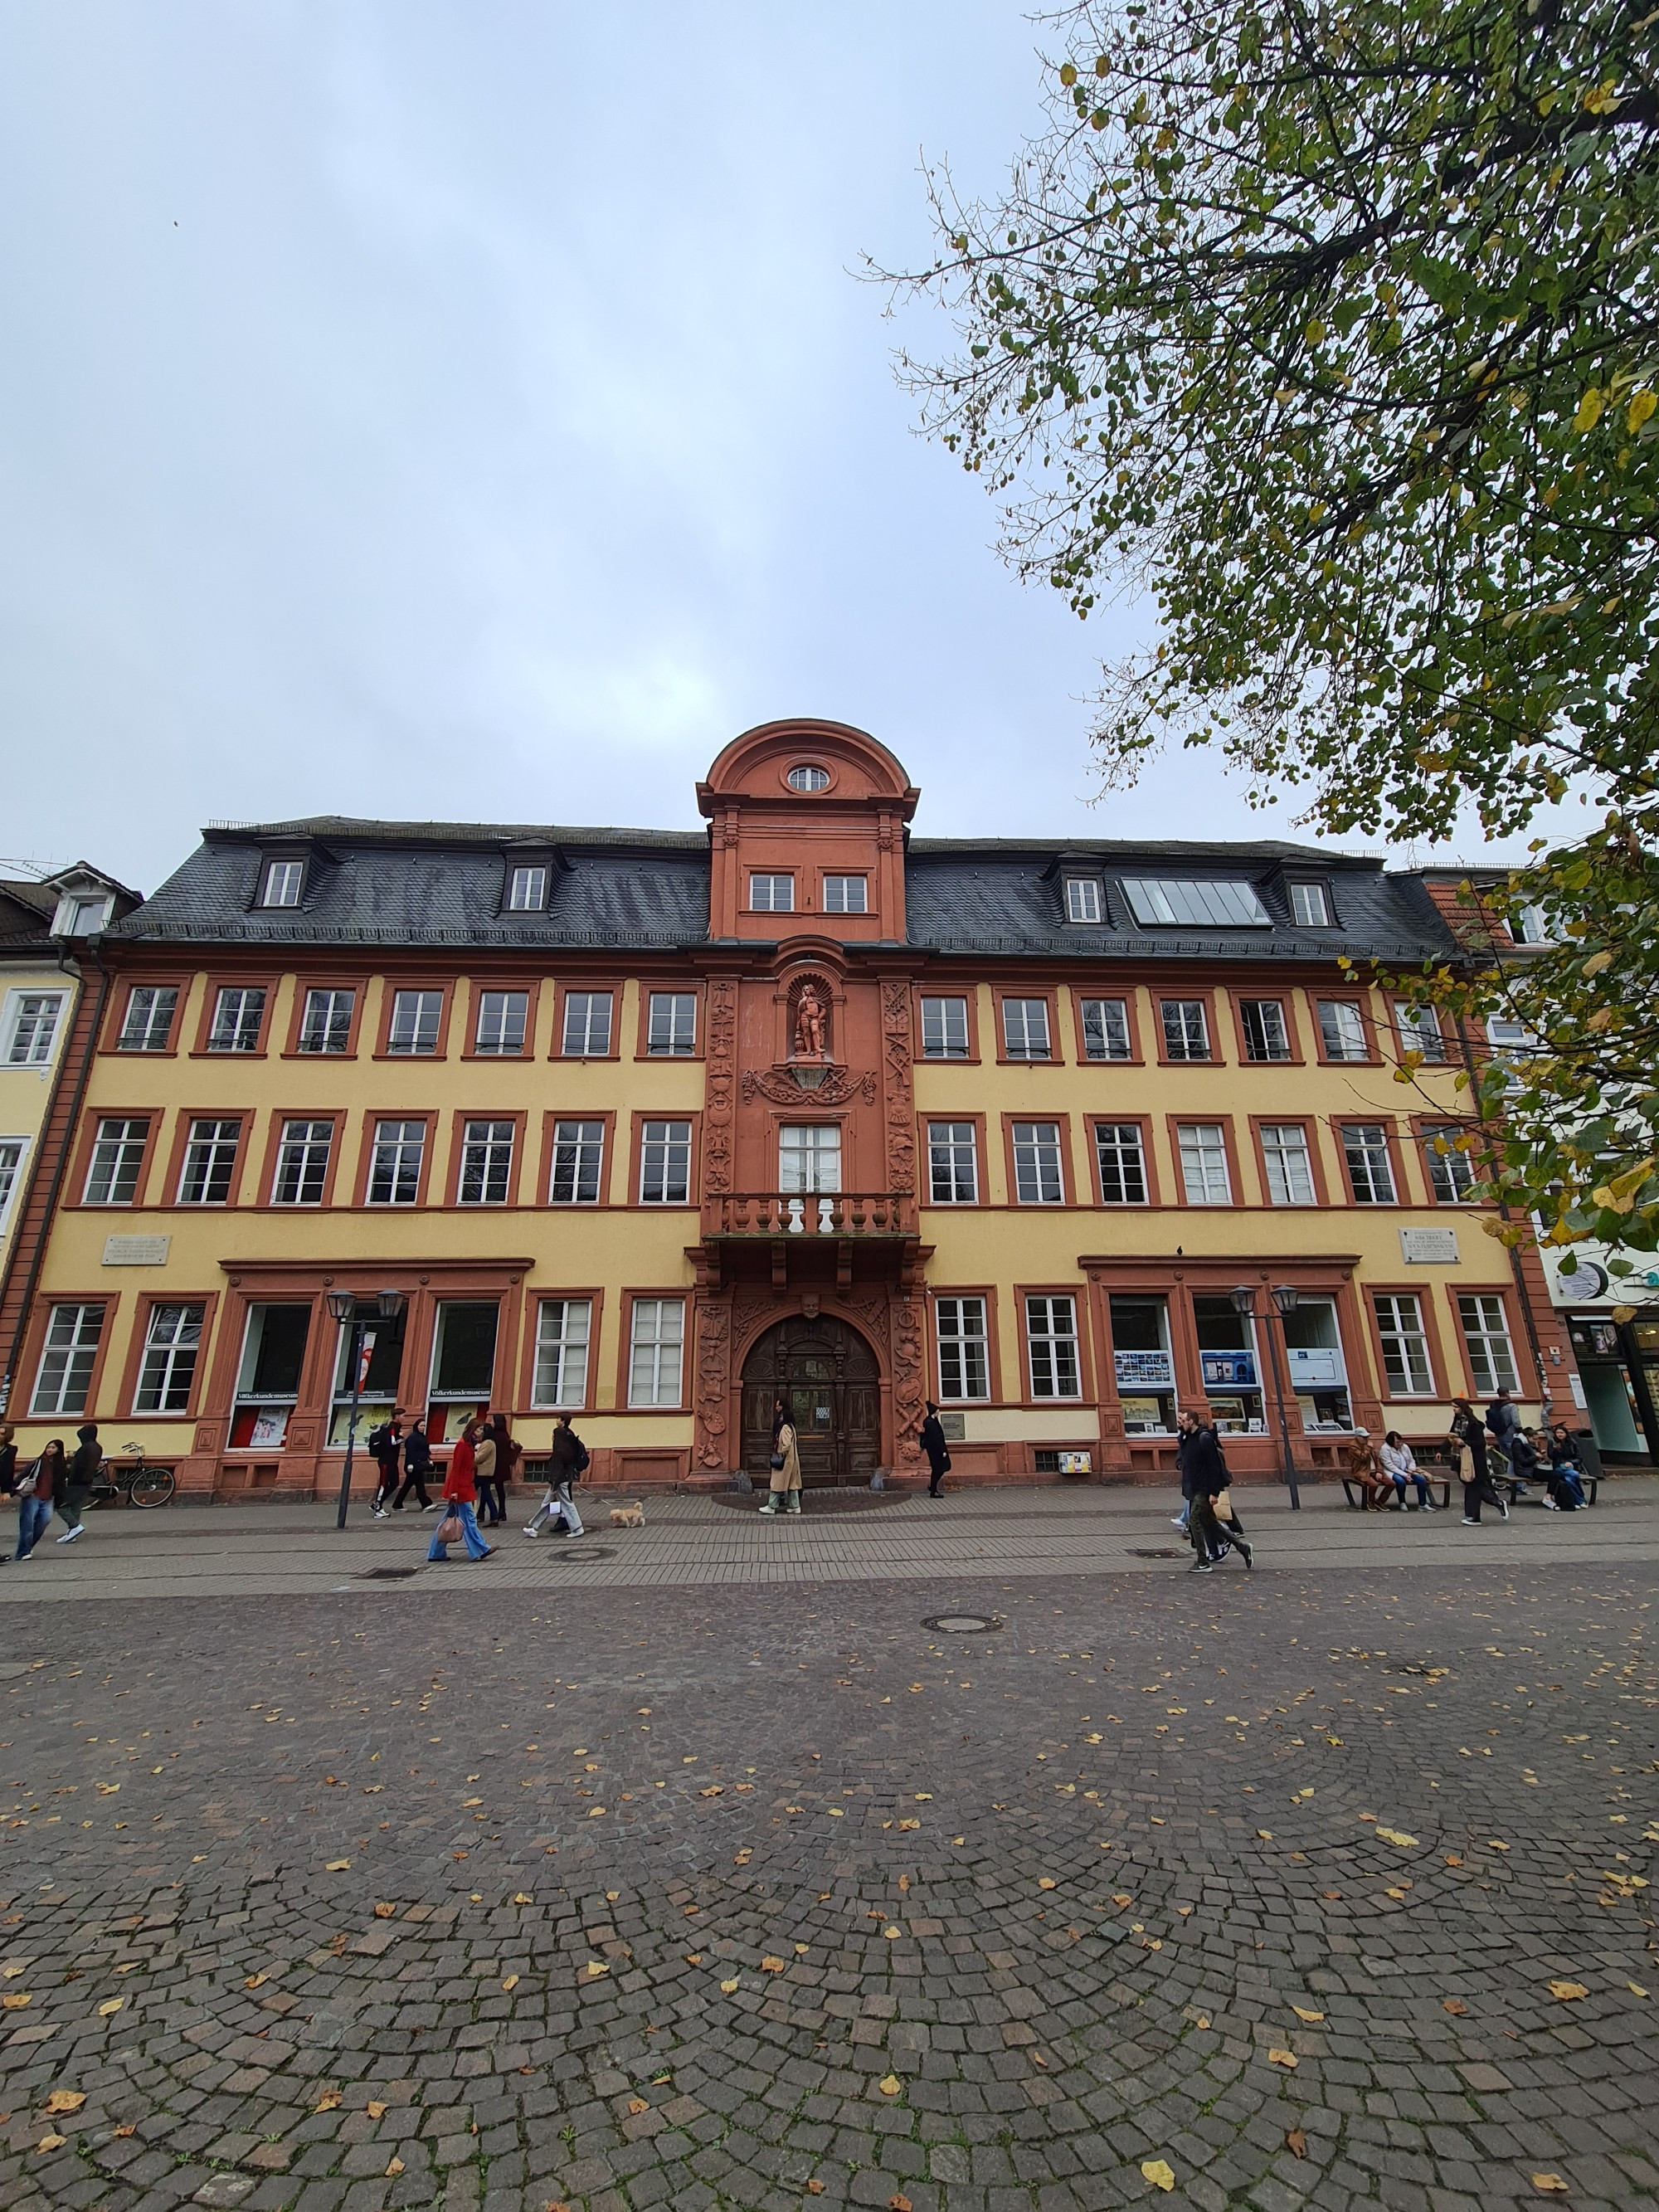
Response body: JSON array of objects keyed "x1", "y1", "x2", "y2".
[{"x1": 743, "y1": 1314, "x2": 880, "y2": 1484}]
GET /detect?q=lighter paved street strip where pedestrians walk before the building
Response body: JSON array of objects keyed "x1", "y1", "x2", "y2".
[{"x1": 0, "y1": 1475, "x2": 1659, "y2": 1608}]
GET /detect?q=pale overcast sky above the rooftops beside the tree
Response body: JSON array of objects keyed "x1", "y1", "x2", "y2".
[{"x1": 0, "y1": 0, "x2": 1574, "y2": 889}]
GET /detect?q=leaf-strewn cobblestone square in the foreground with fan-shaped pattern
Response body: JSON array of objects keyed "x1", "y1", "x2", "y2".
[{"x1": 0, "y1": 1551, "x2": 1659, "y2": 2212}]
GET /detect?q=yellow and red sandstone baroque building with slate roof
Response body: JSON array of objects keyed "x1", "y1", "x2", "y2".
[{"x1": 0, "y1": 721, "x2": 1570, "y2": 1495}]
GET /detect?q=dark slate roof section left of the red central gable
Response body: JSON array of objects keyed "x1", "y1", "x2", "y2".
[{"x1": 110, "y1": 814, "x2": 708, "y2": 949}]
